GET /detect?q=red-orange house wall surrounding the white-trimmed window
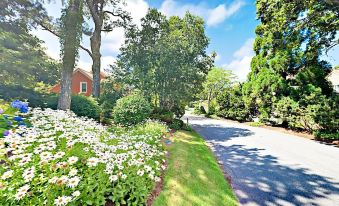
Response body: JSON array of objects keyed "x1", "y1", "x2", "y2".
[{"x1": 51, "y1": 72, "x2": 92, "y2": 96}]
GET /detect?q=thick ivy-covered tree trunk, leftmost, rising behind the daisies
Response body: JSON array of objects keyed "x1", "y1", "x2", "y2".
[{"x1": 58, "y1": 0, "x2": 82, "y2": 110}]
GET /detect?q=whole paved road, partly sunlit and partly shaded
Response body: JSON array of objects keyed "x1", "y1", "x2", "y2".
[{"x1": 184, "y1": 115, "x2": 339, "y2": 206}]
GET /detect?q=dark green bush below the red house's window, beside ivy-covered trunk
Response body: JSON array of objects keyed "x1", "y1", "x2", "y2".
[{"x1": 71, "y1": 95, "x2": 100, "y2": 120}]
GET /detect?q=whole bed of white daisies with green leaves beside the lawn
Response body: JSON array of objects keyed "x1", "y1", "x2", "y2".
[{"x1": 0, "y1": 104, "x2": 167, "y2": 206}]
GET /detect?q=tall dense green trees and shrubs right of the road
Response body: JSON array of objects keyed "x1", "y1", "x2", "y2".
[{"x1": 218, "y1": 0, "x2": 339, "y2": 138}]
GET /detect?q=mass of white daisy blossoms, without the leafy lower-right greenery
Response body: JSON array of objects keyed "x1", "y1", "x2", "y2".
[{"x1": 0, "y1": 109, "x2": 165, "y2": 205}]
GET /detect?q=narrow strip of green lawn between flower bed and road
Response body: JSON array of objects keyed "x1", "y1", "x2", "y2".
[{"x1": 154, "y1": 131, "x2": 238, "y2": 206}]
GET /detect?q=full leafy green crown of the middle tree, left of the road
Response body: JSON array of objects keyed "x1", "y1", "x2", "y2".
[{"x1": 114, "y1": 9, "x2": 213, "y2": 116}]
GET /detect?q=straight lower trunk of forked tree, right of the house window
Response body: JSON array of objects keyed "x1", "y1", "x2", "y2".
[{"x1": 91, "y1": 26, "x2": 102, "y2": 97}]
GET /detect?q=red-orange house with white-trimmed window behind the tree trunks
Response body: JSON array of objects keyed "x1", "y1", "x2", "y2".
[{"x1": 50, "y1": 68, "x2": 106, "y2": 96}]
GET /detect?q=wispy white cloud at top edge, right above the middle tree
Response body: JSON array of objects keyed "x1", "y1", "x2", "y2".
[{"x1": 160, "y1": 0, "x2": 245, "y2": 26}]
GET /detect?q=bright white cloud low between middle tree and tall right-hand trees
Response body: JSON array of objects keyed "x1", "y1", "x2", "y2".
[{"x1": 223, "y1": 38, "x2": 254, "y2": 81}]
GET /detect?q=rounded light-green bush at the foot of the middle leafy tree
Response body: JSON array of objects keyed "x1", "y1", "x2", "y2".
[{"x1": 112, "y1": 94, "x2": 152, "y2": 126}]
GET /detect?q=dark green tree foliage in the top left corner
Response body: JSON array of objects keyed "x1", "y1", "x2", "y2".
[{"x1": 0, "y1": 0, "x2": 60, "y2": 88}]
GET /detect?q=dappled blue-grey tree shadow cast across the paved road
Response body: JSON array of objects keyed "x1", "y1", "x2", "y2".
[{"x1": 193, "y1": 125, "x2": 339, "y2": 206}]
